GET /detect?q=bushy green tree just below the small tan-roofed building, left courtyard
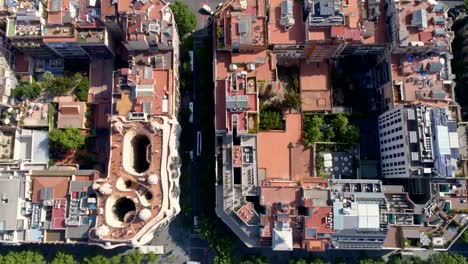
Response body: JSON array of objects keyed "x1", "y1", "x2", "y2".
[{"x1": 49, "y1": 128, "x2": 85, "y2": 150}]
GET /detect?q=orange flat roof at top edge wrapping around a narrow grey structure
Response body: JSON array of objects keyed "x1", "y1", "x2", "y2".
[{"x1": 268, "y1": 0, "x2": 305, "y2": 44}]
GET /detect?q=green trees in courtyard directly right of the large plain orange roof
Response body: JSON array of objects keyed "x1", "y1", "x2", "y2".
[{"x1": 303, "y1": 113, "x2": 360, "y2": 145}]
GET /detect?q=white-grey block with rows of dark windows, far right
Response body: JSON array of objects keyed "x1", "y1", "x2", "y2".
[{"x1": 378, "y1": 105, "x2": 460, "y2": 178}]
